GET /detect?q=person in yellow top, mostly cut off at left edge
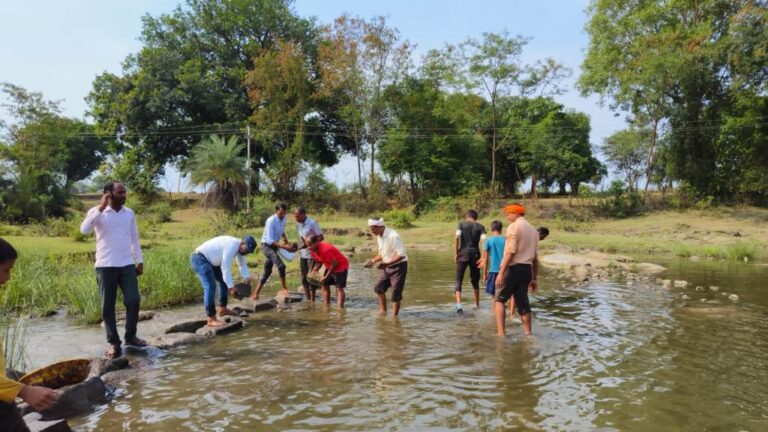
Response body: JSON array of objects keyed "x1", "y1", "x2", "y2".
[{"x1": 0, "y1": 238, "x2": 58, "y2": 432}]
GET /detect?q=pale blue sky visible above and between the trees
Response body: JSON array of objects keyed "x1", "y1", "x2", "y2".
[{"x1": 0, "y1": 0, "x2": 624, "y2": 188}]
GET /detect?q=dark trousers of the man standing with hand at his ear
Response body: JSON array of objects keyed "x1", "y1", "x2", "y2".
[{"x1": 96, "y1": 264, "x2": 141, "y2": 345}]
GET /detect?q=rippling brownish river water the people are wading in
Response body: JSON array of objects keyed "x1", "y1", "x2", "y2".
[{"x1": 22, "y1": 251, "x2": 768, "y2": 431}]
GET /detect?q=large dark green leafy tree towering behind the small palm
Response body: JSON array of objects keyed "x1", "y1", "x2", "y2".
[{"x1": 88, "y1": 0, "x2": 316, "y2": 197}]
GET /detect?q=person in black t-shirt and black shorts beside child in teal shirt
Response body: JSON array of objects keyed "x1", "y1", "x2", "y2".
[{"x1": 453, "y1": 209, "x2": 485, "y2": 314}]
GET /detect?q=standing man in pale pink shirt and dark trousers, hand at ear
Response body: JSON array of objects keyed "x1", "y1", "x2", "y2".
[{"x1": 80, "y1": 182, "x2": 147, "y2": 358}]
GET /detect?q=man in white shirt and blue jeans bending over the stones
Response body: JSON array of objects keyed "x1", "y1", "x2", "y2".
[{"x1": 189, "y1": 235, "x2": 256, "y2": 327}]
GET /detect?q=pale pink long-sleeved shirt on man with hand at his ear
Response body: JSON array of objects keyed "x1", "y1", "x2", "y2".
[{"x1": 80, "y1": 206, "x2": 143, "y2": 267}]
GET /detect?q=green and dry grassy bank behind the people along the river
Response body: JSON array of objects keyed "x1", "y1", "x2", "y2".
[{"x1": 0, "y1": 200, "x2": 768, "y2": 322}]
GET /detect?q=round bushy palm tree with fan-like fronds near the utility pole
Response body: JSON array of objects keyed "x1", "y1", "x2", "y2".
[{"x1": 186, "y1": 135, "x2": 248, "y2": 209}]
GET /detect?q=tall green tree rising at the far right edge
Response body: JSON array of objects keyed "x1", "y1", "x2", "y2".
[{"x1": 579, "y1": 0, "x2": 768, "y2": 198}]
